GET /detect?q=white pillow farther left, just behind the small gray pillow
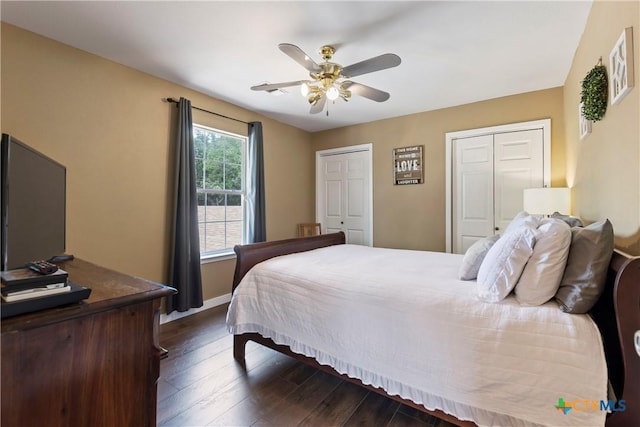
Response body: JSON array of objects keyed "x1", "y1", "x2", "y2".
[{"x1": 477, "y1": 225, "x2": 536, "y2": 302}]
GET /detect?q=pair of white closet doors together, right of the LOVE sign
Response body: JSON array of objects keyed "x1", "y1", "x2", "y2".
[{"x1": 452, "y1": 129, "x2": 544, "y2": 253}]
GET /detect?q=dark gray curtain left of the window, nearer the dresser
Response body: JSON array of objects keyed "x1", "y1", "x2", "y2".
[{"x1": 166, "y1": 98, "x2": 202, "y2": 313}]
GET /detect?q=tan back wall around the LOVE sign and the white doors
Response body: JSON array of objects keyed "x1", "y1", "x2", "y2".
[{"x1": 312, "y1": 88, "x2": 565, "y2": 251}]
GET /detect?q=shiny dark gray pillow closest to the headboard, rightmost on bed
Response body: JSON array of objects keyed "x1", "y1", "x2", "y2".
[{"x1": 556, "y1": 219, "x2": 614, "y2": 314}]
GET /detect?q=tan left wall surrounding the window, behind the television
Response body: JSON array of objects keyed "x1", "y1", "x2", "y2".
[{"x1": 1, "y1": 23, "x2": 315, "y2": 299}]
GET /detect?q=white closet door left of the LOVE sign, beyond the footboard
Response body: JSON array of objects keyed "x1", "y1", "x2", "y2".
[{"x1": 316, "y1": 151, "x2": 372, "y2": 246}]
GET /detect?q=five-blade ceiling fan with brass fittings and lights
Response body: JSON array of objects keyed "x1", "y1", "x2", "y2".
[{"x1": 251, "y1": 43, "x2": 400, "y2": 114}]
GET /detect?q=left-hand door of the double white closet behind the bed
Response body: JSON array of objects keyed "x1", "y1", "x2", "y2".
[{"x1": 453, "y1": 135, "x2": 494, "y2": 253}]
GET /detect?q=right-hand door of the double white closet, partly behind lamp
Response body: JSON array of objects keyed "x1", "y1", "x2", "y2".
[{"x1": 494, "y1": 129, "x2": 544, "y2": 233}]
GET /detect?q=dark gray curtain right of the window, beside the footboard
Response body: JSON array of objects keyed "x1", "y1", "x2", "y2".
[{"x1": 247, "y1": 122, "x2": 267, "y2": 243}]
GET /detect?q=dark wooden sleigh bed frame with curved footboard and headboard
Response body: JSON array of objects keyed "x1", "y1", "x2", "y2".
[{"x1": 233, "y1": 232, "x2": 640, "y2": 427}]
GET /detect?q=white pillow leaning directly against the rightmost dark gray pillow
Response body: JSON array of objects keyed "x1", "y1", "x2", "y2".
[{"x1": 514, "y1": 218, "x2": 571, "y2": 306}]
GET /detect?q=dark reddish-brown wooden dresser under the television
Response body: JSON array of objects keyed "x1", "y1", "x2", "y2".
[{"x1": 0, "y1": 259, "x2": 175, "y2": 427}]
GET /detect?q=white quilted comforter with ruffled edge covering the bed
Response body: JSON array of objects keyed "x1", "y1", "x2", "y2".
[{"x1": 227, "y1": 245, "x2": 607, "y2": 426}]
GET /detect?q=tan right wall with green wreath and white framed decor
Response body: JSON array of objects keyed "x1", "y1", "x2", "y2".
[{"x1": 564, "y1": 0, "x2": 640, "y2": 255}]
